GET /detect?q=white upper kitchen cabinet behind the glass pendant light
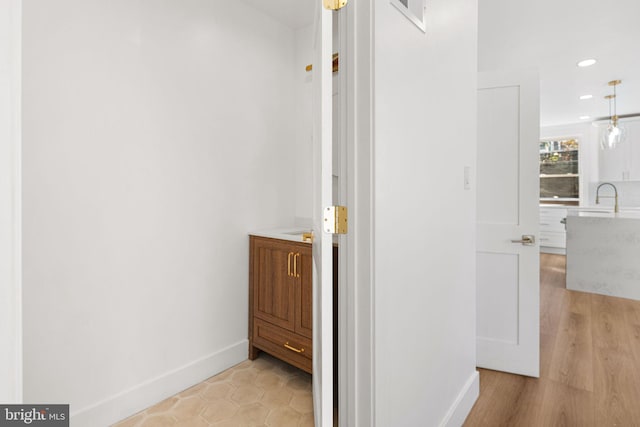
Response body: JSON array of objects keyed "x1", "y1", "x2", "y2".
[{"x1": 598, "y1": 120, "x2": 640, "y2": 182}]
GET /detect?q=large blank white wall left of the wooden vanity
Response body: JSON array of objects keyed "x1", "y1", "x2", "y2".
[{"x1": 24, "y1": 0, "x2": 295, "y2": 425}]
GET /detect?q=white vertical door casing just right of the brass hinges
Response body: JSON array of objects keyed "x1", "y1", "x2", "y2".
[{"x1": 340, "y1": 0, "x2": 375, "y2": 426}]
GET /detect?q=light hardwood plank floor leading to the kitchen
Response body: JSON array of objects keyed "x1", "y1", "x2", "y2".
[{"x1": 464, "y1": 254, "x2": 640, "y2": 427}]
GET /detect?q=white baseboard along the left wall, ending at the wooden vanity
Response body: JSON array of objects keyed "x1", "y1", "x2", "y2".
[{"x1": 71, "y1": 340, "x2": 249, "y2": 427}]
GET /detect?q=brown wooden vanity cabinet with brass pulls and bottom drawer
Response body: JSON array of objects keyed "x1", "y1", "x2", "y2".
[{"x1": 249, "y1": 236, "x2": 313, "y2": 373}]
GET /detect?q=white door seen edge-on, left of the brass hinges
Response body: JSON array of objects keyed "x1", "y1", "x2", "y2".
[{"x1": 313, "y1": 0, "x2": 333, "y2": 427}]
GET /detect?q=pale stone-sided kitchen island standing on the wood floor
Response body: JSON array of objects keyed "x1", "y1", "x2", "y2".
[{"x1": 567, "y1": 209, "x2": 640, "y2": 300}]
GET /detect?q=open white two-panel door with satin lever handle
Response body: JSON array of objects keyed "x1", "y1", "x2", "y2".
[{"x1": 476, "y1": 72, "x2": 540, "y2": 377}]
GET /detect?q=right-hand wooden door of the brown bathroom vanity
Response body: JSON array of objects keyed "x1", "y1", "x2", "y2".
[{"x1": 295, "y1": 248, "x2": 313, "y2": 338}]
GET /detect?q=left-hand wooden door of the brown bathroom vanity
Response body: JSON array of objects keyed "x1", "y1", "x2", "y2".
[{"x1": 251, "y1": 238, "x2": 296, "y2": 331}]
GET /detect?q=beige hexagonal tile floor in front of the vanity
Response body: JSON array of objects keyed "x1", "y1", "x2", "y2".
[{"x1": 113, "y1": 353, "x2": 313, "y2": 427}]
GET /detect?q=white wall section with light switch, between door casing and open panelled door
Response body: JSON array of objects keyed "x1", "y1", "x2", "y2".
[{"x1": 373, "y1": 0, "x2": 478, "y2": 426}]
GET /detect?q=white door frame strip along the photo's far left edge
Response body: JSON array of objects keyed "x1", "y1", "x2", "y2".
[{"x1": 0, "y1": 0, "x2": 22, "y2": 403}]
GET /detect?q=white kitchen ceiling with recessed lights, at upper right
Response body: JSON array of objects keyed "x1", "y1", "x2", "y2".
[{"x1": 478, "y1": 0, "x2": 640, "y2": 126}]
